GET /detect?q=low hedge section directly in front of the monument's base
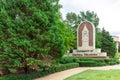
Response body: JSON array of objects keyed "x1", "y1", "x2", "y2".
[{"x1": 59, "y1": 57, "x2": 119, "y2": 67}]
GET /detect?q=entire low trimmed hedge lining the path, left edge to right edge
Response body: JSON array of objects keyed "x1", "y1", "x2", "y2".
[{"x1": 0, "y1": 57, "x2": 119, "y2": 80}]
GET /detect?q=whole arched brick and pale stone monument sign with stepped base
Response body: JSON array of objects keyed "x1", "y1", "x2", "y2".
[{"x1": 72, "y1": 21, "x2": 107, "y2": 58}]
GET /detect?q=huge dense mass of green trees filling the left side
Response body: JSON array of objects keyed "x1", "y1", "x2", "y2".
[{"x1": 0, "y1": 0, "x2": 72, "y2": 73}]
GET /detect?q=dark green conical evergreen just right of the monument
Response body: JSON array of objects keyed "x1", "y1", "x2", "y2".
[{"x1": 101, "y1": 28, "x2": 116, "y2": 57}]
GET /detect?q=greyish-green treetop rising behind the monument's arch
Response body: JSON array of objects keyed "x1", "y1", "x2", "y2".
[{"x1": 66, "y1": 11, "x2": 99, "y2": 29}]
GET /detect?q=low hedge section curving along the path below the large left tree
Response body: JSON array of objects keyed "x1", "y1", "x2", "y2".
[{"x1": 0, "y1": 63, "x2": 79, "y2": 80}]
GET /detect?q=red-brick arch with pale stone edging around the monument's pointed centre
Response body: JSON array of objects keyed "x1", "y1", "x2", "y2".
[{"x1": 77, "y1": 21, "x2": 95, "y2": 48}]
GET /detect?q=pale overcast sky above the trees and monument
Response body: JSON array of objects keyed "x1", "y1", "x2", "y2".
[{"x1": 60, "y1": 0, "x2": 120, "y2": 37}]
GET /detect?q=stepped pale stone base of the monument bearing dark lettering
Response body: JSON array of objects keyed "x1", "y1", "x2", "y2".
[{"x1": 71, "y1": 49, "x2": 108, "y2": 58}]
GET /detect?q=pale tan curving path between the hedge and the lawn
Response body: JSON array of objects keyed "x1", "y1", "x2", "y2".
[{"x1": 34, "y1": 64, "x2": 120, "y2": 80}]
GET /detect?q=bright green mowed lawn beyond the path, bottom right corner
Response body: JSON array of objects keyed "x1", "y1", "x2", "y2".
[{"x1": 64, "y1": 70, "x2": 120, "y2": 80}]
